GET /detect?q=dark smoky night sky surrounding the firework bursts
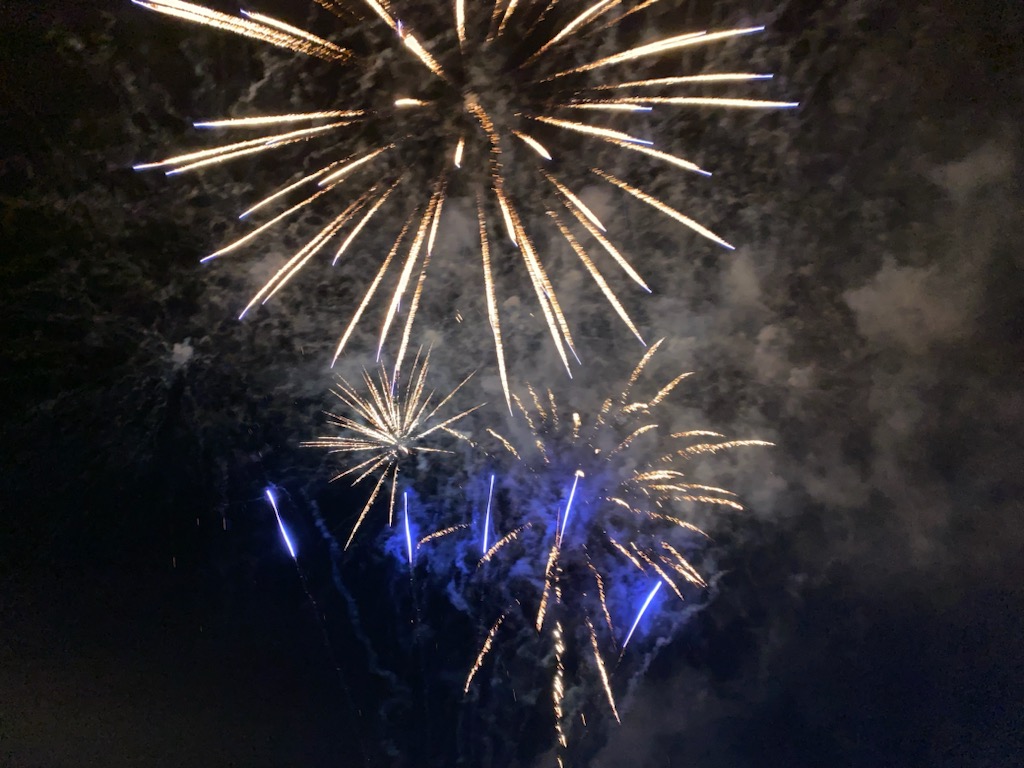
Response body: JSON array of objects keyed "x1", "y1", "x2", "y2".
[{"x1": 0, "y1": 0, "x2": 1024, "y2": 768}]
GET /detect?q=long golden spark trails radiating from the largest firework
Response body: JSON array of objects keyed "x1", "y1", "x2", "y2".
[{"x1": 134, "y1": 0, "x2": 796, "y2": 385}]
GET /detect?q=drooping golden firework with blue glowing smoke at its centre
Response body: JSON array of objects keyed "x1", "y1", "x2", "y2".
[{"x1": 466, "y1": 341, "x2": 771, "y2": 749}]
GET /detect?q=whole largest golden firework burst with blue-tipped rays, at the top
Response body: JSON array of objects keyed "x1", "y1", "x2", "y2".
[{"x1": 133, "y1": 0, "x2": 796, "y2": 411}]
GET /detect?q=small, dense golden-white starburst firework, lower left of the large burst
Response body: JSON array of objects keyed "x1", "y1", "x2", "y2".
[{"x1": 302, "y1": 352, "x2": 480, "y2": 548}]
